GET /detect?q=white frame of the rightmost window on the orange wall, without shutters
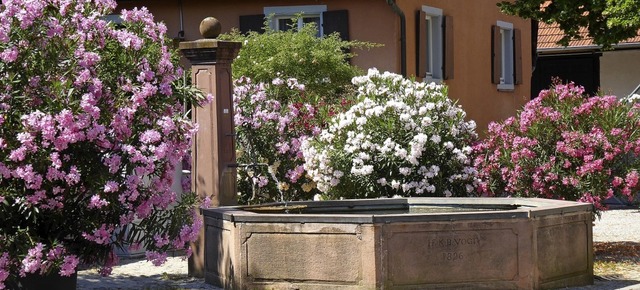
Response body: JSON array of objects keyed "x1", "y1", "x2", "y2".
[{"x1": 496, "y1": 21, "x2": 515, "y2": 91}]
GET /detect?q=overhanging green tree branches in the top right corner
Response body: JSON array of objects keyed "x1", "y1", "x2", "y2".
[{"x1": 498, "y1": 0, "x2": 640, "y2": 49}]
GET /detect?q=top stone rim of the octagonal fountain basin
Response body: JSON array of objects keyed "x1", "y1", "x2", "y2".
[{"x1": 201, "y1": 197, "x2": 593, "y2": 224}]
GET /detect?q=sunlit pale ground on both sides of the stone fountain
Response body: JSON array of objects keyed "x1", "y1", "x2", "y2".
[{"x1": 78, "y1": 209, "x2": 640, "y2": 290}]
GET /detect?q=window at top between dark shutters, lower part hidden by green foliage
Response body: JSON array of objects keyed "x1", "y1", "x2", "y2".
[{"x1": 264, "y1": 5, "x2": 327, "y2": 37}]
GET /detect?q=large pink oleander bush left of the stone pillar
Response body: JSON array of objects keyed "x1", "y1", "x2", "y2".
[{"x1": 0, "y1": 0, "x2": 208, "y2": 289}]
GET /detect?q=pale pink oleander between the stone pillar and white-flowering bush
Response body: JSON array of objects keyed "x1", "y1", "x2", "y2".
[{"x1": 233, "y1": 77, "x2": 345, "y2": 204}]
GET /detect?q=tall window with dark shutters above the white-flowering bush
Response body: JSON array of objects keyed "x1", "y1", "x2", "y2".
[{"x1": 416, "y1": 6, "x2": 453, "y2": 82}]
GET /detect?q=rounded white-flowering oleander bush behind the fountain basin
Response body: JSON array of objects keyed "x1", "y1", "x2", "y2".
[{"x1": 302, "y1": 69, "x2": 476, "y2": 199}]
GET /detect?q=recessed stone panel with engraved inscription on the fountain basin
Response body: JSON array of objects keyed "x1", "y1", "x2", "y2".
[{"x1": 386, "y1": 229, "x2": 518, "y2": 284}]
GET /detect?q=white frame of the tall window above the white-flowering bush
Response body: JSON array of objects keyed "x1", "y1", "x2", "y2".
[{"x1": 422, "y1": 5, "x2": 444, "y2": 83}]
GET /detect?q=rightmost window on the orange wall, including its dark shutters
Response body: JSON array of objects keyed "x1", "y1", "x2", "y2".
[{"x1": 491, "y1": 21, "x2": 522, "y2": 91}]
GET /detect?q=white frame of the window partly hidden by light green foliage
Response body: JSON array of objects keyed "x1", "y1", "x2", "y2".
[{"x1": 264, "y1": 5, "x2": 327, "y2": 36}]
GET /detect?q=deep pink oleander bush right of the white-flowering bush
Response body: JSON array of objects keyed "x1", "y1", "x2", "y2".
[{"x1": 474, "y1": 83, "x2": 640, "y2": 210}]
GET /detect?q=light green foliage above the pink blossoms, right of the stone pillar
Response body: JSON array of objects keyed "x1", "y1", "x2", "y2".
[{"x1": 219, "y1": 21, "x2": 375, "y2": 97}]
